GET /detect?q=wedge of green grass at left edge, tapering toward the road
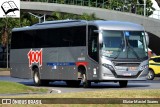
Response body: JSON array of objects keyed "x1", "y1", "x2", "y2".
[{"x1": 0, "y1": 81, "x2": 47, "y2": 94}]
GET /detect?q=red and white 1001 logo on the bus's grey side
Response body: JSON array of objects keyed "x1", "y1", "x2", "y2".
[{"x1": 28, "y1": 49, "x2": 42, "y2": 67}]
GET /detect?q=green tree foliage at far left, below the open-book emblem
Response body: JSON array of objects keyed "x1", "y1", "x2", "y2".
[{"x1": 0, "y1": 13, "x2": 38, "y2": 47}]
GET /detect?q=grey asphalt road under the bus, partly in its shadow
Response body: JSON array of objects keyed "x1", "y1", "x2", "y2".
[{"x1": 0, "y1": 76, "x2": 160, "y2": 93}]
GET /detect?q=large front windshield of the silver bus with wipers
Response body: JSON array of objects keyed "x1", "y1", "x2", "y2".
[{"x1": 100, "y1": 30, "x2": 147, "y2": 59}]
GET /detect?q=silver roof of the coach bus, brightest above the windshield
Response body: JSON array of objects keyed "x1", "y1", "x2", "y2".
[{"x1": 12, "y1": 20, "x2": 144, "y2": 32}]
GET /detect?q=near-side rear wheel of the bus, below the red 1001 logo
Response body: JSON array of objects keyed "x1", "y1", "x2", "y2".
[{"x1": 33, "y1": 68, "x2": 49, "y2": 86}]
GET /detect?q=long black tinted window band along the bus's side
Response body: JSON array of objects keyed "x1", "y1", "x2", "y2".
[{"x1": 11, "y1": 26, "x2": 86, "y2": 49}]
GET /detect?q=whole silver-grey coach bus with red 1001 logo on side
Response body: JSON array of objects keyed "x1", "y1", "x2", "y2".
[{"x1": 10, "y1": 20, "x2": 148, "y2": 87}]
